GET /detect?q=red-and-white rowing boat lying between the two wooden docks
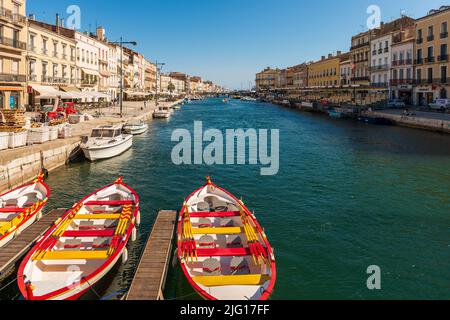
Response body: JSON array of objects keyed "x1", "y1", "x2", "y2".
[{"x1": 18, "y1": 178, "x2": 140, "y2": 300}]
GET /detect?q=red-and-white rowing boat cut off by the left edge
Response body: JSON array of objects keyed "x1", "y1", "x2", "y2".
[{"x1": 0, "y1": 174, "x2": 50, "y2": 248}]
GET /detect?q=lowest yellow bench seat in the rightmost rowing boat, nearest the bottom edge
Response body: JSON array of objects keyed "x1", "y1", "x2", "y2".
[{"x1": 192, "y1": 274, "x2": 270, "y2": 287}]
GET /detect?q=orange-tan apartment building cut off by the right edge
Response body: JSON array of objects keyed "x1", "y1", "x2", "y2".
[{"x1": 414, "y1": 6, "x2": 450, "y2": 105}]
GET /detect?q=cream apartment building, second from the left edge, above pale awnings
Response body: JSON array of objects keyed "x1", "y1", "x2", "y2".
[{"x1": 26, "y1": 17, "x2": 79, "y2": 106}]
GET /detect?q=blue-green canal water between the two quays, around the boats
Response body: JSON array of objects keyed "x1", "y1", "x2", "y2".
[{"x1": 0, "y1": 99, "x2": 450, "y2": 299}]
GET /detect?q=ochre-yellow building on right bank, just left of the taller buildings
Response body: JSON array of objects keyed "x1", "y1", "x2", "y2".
[{"x1": 308, "y1": 51, "x2": 341, "y2": 88}]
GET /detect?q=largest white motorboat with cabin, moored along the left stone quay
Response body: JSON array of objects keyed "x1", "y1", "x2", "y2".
[{"x1": 81, "y1": 126, "x2": 133, "y2": 161}]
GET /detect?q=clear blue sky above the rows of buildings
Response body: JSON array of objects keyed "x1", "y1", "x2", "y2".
[{"x1": 27, "y1": 0, "x2": 448, "y2": 89}]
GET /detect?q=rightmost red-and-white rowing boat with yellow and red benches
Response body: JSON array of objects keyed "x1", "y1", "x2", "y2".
[{"x1": 178, "y1": 177, "x2": 276, "y2": 300}]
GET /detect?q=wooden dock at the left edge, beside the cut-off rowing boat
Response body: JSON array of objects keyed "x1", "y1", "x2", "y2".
[{"x1": 0, "y1": 209, "x2": 66, "y2": 279}]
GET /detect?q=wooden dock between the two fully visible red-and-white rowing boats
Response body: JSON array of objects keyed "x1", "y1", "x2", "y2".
[{"x1": 126, "y1": 211, "x2": 177, "y2": 300}]
